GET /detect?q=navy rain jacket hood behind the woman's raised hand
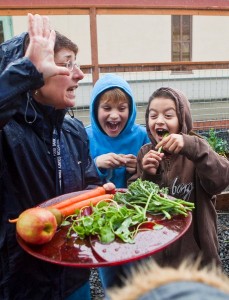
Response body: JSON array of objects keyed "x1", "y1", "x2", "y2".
[{"x1": 0, "y1": 32, "x2": 28, "y2": 74}]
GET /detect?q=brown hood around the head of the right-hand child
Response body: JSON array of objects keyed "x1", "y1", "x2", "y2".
[{"x1": 145, "y1": 87, "x2": 193, "y2": 145}]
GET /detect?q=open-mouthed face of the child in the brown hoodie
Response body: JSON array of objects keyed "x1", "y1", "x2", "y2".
[{"x1": 148, "y1": 97, "x2": 180, "y2": 143}]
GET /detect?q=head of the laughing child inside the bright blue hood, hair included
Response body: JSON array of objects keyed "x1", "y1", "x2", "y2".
[{"x1": 97, "y1": 88, "x2": 130, "y2": 137}]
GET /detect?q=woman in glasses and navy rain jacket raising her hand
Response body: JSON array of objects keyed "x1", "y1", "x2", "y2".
[{"x1": 0, "y1": 14, "x2": 114, "y2": 300}]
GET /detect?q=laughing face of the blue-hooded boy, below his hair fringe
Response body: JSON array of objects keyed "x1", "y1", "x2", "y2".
[{"x1": 98, "y1": 100, "x2": 129, "y2": 137}]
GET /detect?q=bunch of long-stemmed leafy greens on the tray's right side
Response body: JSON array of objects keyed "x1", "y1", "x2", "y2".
[{"x1": 114, "y1": 179, "x2": 194, "y2": 219}]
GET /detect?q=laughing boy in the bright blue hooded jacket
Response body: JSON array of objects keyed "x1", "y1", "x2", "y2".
[{"x1": 86, "y1": 74, "x2": 149, "y2": 188}]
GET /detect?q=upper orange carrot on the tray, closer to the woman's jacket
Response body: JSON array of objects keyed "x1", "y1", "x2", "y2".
[{"x1": 50, "y1": 186, "x2": 106, "y2": 209}]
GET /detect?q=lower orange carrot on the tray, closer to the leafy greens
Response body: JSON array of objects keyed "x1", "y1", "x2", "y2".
[{"x1": 59, "y1": 194, "x2": 114, "y2": 217}]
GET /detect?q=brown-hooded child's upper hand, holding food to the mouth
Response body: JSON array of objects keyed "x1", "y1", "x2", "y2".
[{"x1": 155, "y1": 133, "x2": 184, "y2": 154}]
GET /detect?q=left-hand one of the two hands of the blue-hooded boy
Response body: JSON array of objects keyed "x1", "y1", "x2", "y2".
[{"x1": 95, "y1": 153, "x2": 126, "y2": 169}]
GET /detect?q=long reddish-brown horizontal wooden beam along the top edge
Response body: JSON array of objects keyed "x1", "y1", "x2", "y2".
[{"x1": 0, "y1": 0, "x2": 229, "y2": 16}]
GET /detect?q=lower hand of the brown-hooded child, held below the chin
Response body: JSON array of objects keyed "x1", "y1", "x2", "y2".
[{"x1": 142, "y1": 150, "x2": 164, "y2": 175}]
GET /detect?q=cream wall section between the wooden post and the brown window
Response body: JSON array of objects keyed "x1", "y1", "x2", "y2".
[{"x1": 97, "y1": 16, "x2": 171, "y2": 64}]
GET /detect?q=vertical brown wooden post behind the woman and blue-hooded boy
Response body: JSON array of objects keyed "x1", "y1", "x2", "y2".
[{"x1": 90, "y1": 7, "x2": 99, "y2": 85}]
